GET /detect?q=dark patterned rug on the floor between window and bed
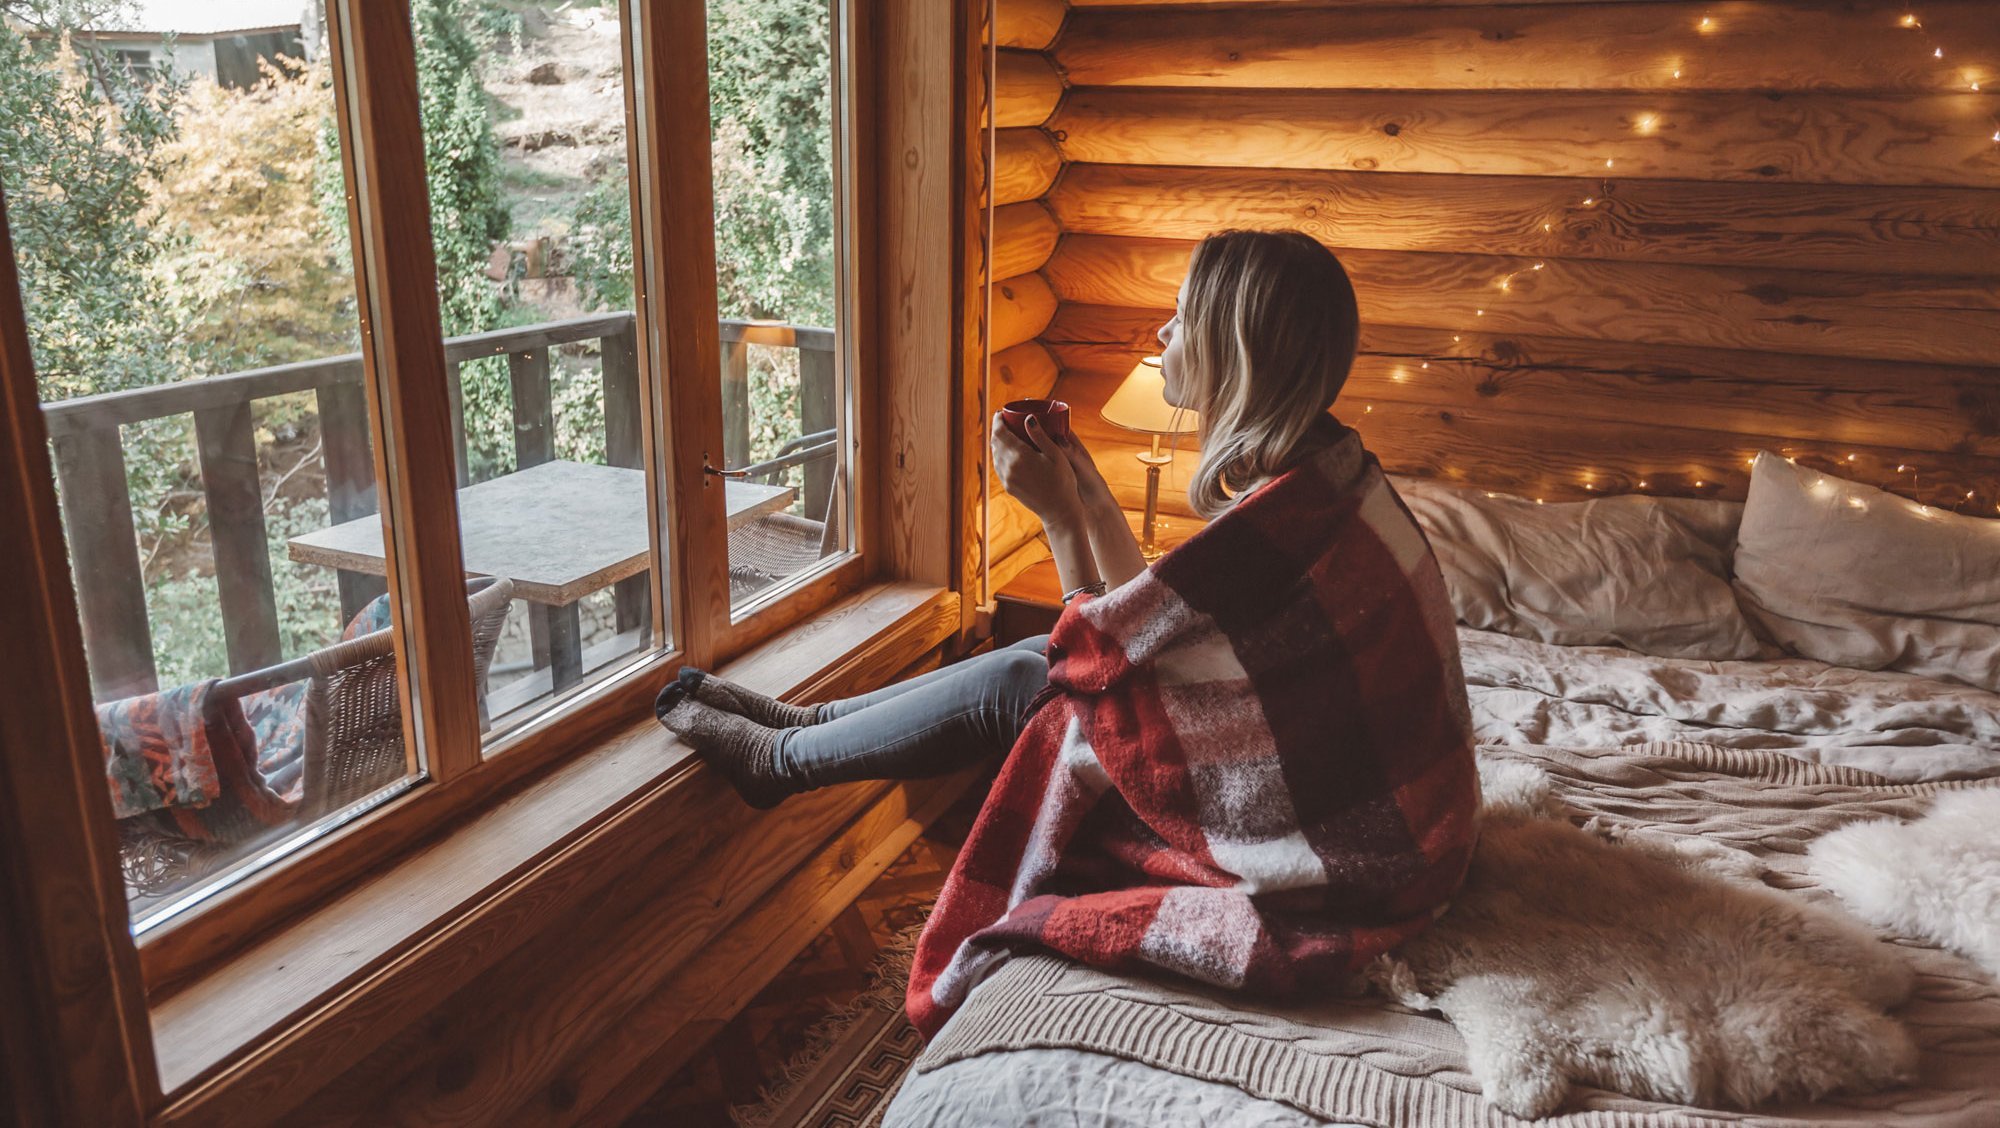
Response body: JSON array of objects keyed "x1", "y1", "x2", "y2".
[{"x1": 732, "y1": 924, "x2": 924, "y2": 1128}]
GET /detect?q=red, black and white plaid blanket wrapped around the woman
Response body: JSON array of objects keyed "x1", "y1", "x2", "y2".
[{"x1": 906, "y1": 418, "x2": 1478, "y2": 1036}]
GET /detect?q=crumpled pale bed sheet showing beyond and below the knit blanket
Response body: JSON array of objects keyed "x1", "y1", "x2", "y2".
[{"x1": 884, "y1": 628, "x2": 2000, "y2": 1128}]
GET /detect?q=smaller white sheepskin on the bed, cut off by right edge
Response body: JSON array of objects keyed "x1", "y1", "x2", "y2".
[{"x1": 1806, "y1": 788, "x2": 2000, "y2": 976}]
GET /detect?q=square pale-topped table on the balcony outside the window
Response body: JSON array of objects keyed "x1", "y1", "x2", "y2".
[{"x1": 288, "y1": 460, "x2": 798, "y2": 694}]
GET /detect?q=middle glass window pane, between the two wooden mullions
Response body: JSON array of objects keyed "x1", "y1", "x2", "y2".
[{"x1": 410, "y1": 0, "x2": 658, "y2": 744}]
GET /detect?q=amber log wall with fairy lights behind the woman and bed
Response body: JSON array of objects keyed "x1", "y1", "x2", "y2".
[{"x1": 1016, "y1": 0, "x2": 2000, "y2": 516}]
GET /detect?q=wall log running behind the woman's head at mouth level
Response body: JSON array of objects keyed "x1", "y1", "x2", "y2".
[{"x1": 1052, "y1": 326, "x2": 2000, "y2": 458}]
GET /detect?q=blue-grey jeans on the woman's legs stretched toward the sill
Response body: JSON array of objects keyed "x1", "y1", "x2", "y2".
[{"x1": 776, "y1": 634, "x2": 1048, "y2": 788}]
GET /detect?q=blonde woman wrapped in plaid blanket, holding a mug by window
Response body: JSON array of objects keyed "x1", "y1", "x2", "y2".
[{"x1": 660, "y1": 232, "x2": 1478, "y2": 1034}]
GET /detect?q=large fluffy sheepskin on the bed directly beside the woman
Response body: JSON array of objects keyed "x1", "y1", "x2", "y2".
[{"x1": 1376, "y1": 764, "x2": 1916, "y2": 1116}]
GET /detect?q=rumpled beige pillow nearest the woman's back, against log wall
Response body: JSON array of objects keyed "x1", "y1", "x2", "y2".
[{"x1": 1392, "y1": 478, "x2": 1760, "y2": 660}]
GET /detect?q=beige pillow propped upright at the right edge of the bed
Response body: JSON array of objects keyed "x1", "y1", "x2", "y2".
[{"x1": 1736, "y1": 450, "x2": 2000, "y2": 692}]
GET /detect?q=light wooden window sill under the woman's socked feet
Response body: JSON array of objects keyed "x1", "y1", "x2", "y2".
[{"x1": 152, "y1": 584, "x2": 958, "y2": 1120}]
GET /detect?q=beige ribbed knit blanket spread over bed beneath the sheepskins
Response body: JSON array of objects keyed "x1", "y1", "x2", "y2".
[{"x1": 916, "y1": 744, "x2": 2000, "y2": 1128}]
